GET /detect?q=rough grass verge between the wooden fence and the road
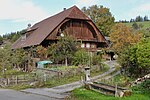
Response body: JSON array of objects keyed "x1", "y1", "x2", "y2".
[{"x1": 3, "y1": 66, "x2": 108, "y2": 90}]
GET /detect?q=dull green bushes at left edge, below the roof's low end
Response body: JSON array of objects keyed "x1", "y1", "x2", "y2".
[{"x1": 0, "y1": 44, "x2": 29, "y2": 73}]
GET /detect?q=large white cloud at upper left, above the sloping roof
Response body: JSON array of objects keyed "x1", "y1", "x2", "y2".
[{"x1": 0, "y1": 0, "x2": 48, "y2": 22}]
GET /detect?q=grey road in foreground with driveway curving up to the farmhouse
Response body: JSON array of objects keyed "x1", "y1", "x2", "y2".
[{"x1": 0, "y1": 61, "x2": 117, "y2": 100}]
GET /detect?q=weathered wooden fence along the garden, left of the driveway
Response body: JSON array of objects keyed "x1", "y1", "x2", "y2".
[{"x1": 0, "y1": 66, "x2": 102, "y2": 87}]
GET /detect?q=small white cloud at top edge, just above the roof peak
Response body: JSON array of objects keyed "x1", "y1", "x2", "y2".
[{"x1": 76, "y1": 0, "x2": 99, "y2": 7}]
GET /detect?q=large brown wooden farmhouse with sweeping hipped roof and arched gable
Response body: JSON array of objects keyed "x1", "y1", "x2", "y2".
[{"x1": 12, "y1": 6, "x2": 107, "y2": 51}]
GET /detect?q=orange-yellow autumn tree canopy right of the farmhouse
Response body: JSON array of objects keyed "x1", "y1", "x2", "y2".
[{"x1": 110, "y1": 23, "x2": 141, "y2": 53}]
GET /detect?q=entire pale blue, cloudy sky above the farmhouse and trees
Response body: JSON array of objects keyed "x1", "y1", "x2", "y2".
[{"x1": 0, "y1": 0, "x2": 150, "y2": 35}]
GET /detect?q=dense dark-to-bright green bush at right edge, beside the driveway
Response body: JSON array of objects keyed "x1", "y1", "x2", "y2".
[{"x1": 118, "y1": 39, "x2": 150, "y2": 77}]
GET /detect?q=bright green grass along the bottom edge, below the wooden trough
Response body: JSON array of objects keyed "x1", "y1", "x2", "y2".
[{"x1": 68, "y1": 88, "x2": 150, "y2": 100}]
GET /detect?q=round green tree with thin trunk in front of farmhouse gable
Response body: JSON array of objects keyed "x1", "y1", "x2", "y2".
[{"x1": 48, "y1": 34, "x2": 77, "y2": 66}]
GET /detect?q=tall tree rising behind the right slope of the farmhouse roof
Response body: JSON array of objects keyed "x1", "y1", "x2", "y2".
[{"x1": 82, "y1": 5, "x2": 115, "y2": 36}]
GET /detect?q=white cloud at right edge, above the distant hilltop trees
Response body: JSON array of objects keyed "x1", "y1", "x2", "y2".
[{"x1": 128, "y1": 4, "x2": 150, "y2": 18}]
